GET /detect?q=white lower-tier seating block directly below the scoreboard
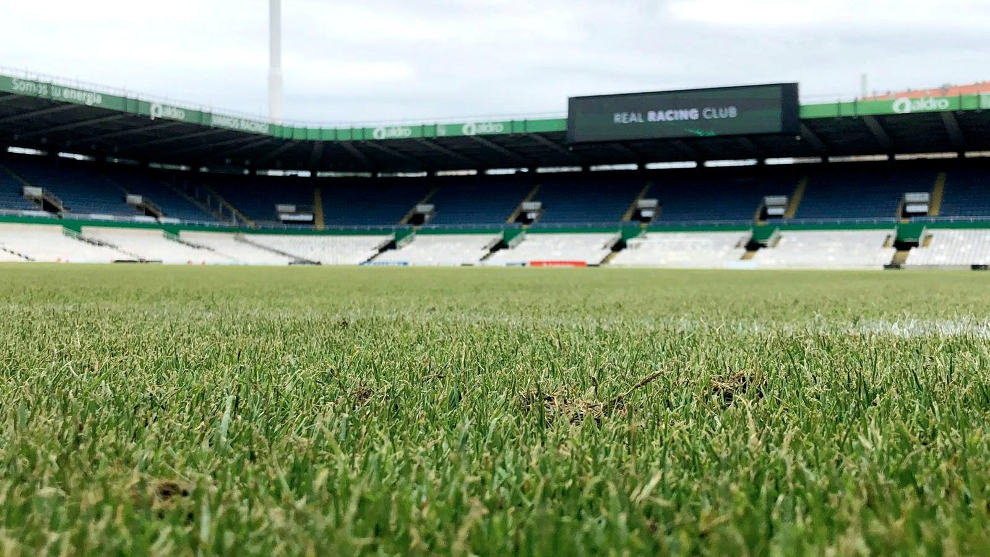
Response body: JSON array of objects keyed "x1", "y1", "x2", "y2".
[{"x1": 609, "y1": 232, "x2": 751, "y2": 269}]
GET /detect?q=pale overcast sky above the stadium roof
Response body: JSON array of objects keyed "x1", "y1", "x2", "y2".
[{"x1": 0, "y1": 0, "x2": 990, "y2": 123}]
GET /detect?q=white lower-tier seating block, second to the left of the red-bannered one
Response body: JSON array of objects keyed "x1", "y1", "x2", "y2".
[{"x1": 243, "y1": 234, "x2": 393, "y2": 265}]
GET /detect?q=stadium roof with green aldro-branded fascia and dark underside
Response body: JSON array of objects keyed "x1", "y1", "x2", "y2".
[{"x1": 0, "y1": 71, "x2": 990, "y2": 172}]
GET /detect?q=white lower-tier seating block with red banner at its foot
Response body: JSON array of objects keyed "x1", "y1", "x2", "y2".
[{"x1": 484, "y1": 232, "x2": 620, "y2": 266}]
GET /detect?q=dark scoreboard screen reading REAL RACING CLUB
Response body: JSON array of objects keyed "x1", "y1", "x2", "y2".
[{"x1": 567, "y1": 83, "x2": 800, "y2": 143}]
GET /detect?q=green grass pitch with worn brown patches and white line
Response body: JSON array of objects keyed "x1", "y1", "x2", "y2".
[{"x1": 0, "y1": 264, "x2": 990, "y2": 555}]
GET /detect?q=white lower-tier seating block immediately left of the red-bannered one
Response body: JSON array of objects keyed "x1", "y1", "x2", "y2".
[{"x1": 375, "y1": 234, "x2": 501, "y2": 266}]
